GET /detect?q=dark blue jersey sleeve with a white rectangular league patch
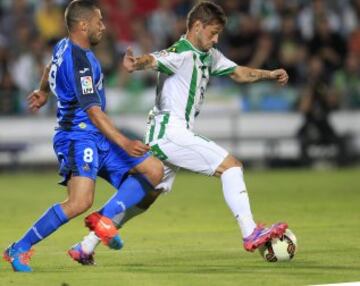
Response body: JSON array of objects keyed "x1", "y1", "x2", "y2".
[{"x1": 69, "y1": 47, "x2": 101, "y2": 111}]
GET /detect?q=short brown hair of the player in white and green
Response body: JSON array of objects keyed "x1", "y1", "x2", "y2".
[{"x1": 186, "y1": 1, "x2": 226, "y2": 30}]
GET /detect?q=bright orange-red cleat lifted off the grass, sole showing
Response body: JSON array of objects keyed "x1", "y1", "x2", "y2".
[{"x1": 85, "y1": 212, "x2": 124, "y2": 250}]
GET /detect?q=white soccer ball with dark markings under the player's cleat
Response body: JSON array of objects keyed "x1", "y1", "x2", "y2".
[{"x1": 259, "y1": 229, "x2": 297, "y2": 262}]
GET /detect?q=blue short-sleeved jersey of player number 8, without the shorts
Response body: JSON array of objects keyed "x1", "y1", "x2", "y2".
[{"x1": 49, "y1": 38, "x2": 106, "y2": 132}]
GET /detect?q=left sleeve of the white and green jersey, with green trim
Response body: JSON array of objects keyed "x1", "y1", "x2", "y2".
[{"x1": 151, "y1": 50, "x2": 184, "y2": 75}]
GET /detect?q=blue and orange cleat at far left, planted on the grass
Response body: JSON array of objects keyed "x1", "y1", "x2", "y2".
[{"x1": 3, "y1": 243, "x2": 34, "y2": 272}]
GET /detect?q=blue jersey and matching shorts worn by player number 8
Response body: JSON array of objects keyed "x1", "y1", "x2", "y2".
[{"x1": 49, "y1": 36, "x2": 149, "y2": 188}]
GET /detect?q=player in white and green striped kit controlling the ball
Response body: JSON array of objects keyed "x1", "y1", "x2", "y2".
[{"x1": 72, "y1": 1, "x2": 288, "y2": 263}]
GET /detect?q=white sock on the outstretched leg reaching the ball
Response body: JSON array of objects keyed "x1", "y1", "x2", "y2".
[{"x1": 221, "y1": 167, "x2": 256, "y2": 238}]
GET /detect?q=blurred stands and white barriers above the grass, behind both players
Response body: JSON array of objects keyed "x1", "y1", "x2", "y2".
[{"x1": 0, "y1": 0, "x2": 360, "y2": 170}]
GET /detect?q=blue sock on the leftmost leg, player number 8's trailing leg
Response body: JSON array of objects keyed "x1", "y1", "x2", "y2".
[{"x1": 14, "y1": 204, "x2": 69, "y2": 251}]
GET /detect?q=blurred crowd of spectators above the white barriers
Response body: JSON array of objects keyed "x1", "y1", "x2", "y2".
[{"x1": 0, "y1": 0, "x2": 360, "y2": 115}]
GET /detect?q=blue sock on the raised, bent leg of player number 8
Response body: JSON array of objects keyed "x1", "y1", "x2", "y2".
[{"x1": 99, "y1": 174, "x2": 153, "y2": 219}]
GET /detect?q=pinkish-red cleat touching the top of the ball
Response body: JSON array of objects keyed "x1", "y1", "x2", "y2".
[{"x1": 244, "y1": 223, "x2": 288, "y2": 251}]
